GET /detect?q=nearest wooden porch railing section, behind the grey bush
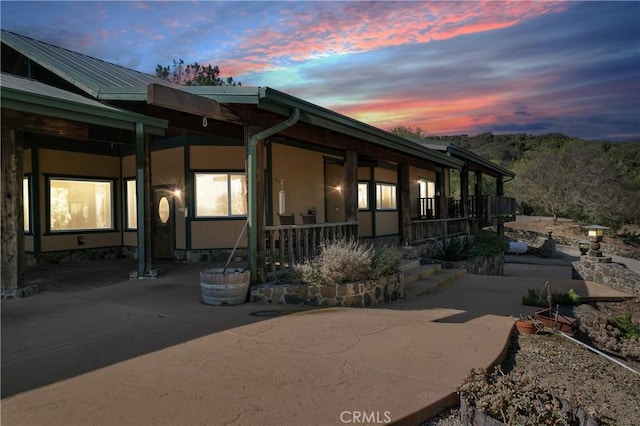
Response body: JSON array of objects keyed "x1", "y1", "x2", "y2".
[{"x1": 259, "y1": 222, "x2": 358, "y2": 281}]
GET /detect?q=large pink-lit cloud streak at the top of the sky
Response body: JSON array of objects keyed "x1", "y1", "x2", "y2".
[{"x1": 232, "y1": 1, "x2": 566, "y2": 72}]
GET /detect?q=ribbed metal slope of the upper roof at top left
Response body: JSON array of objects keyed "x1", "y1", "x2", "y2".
[{"x1": 1, "y1": 30, "x2": 180, "y2": 98}]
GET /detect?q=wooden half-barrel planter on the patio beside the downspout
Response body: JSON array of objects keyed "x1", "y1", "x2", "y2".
[{"x1": 200, "y1": 268, "x2": 251, "y2": 306}]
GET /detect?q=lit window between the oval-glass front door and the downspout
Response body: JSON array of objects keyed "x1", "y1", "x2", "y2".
[{"x1": 195, "y1": 173, "x2": 247, "y2": 217}]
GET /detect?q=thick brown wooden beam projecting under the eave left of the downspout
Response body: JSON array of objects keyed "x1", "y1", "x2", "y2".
[{"x1": 147, "y1": 83, "x2": 227, "y2": 121}]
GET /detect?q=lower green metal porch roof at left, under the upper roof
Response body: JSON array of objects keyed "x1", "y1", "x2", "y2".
[{"x1": 0, "y1": 73, "x2": 167, "y2": 135}]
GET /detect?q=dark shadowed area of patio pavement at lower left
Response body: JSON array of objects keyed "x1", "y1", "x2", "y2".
[{"x1": 1, "y1": 260, "x2": 310, "y2": 398}]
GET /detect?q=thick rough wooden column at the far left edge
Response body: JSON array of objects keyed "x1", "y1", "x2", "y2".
[{"x1": 0, "y1": 116, "x2": 25, "y2": 294}]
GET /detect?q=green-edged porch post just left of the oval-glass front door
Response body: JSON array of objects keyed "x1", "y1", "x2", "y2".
[{"x1": 136, "y1": 123, "x2": 152, "y2": 278}]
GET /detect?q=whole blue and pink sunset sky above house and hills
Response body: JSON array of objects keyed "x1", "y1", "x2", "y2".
[{"x1": 0, "y1": 0, "x2": 640, "y2": 141}]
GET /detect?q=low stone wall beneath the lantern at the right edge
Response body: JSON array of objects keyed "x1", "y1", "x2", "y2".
[{"x1": 571, "y1": 256, "x2": 640, "y2": 295}]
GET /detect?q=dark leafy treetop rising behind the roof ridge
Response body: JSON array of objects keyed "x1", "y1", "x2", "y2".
[{"x1": 156, "y1": 59, "x2": 242, "y2": 86}]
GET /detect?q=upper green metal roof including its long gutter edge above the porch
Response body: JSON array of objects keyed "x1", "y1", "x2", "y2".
[{"x1": 2, "y1": 30, "x2": 463, "y2": 169}]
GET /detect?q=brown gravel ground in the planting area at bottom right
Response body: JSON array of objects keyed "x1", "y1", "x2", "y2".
[{"x1": 423, "y1": 301, "x2": 640, "y2": 426}]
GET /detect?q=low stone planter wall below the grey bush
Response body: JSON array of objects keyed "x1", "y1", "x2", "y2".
[{"x1": 250, "y1": 272, "x2": 404, "y2": 307}]
